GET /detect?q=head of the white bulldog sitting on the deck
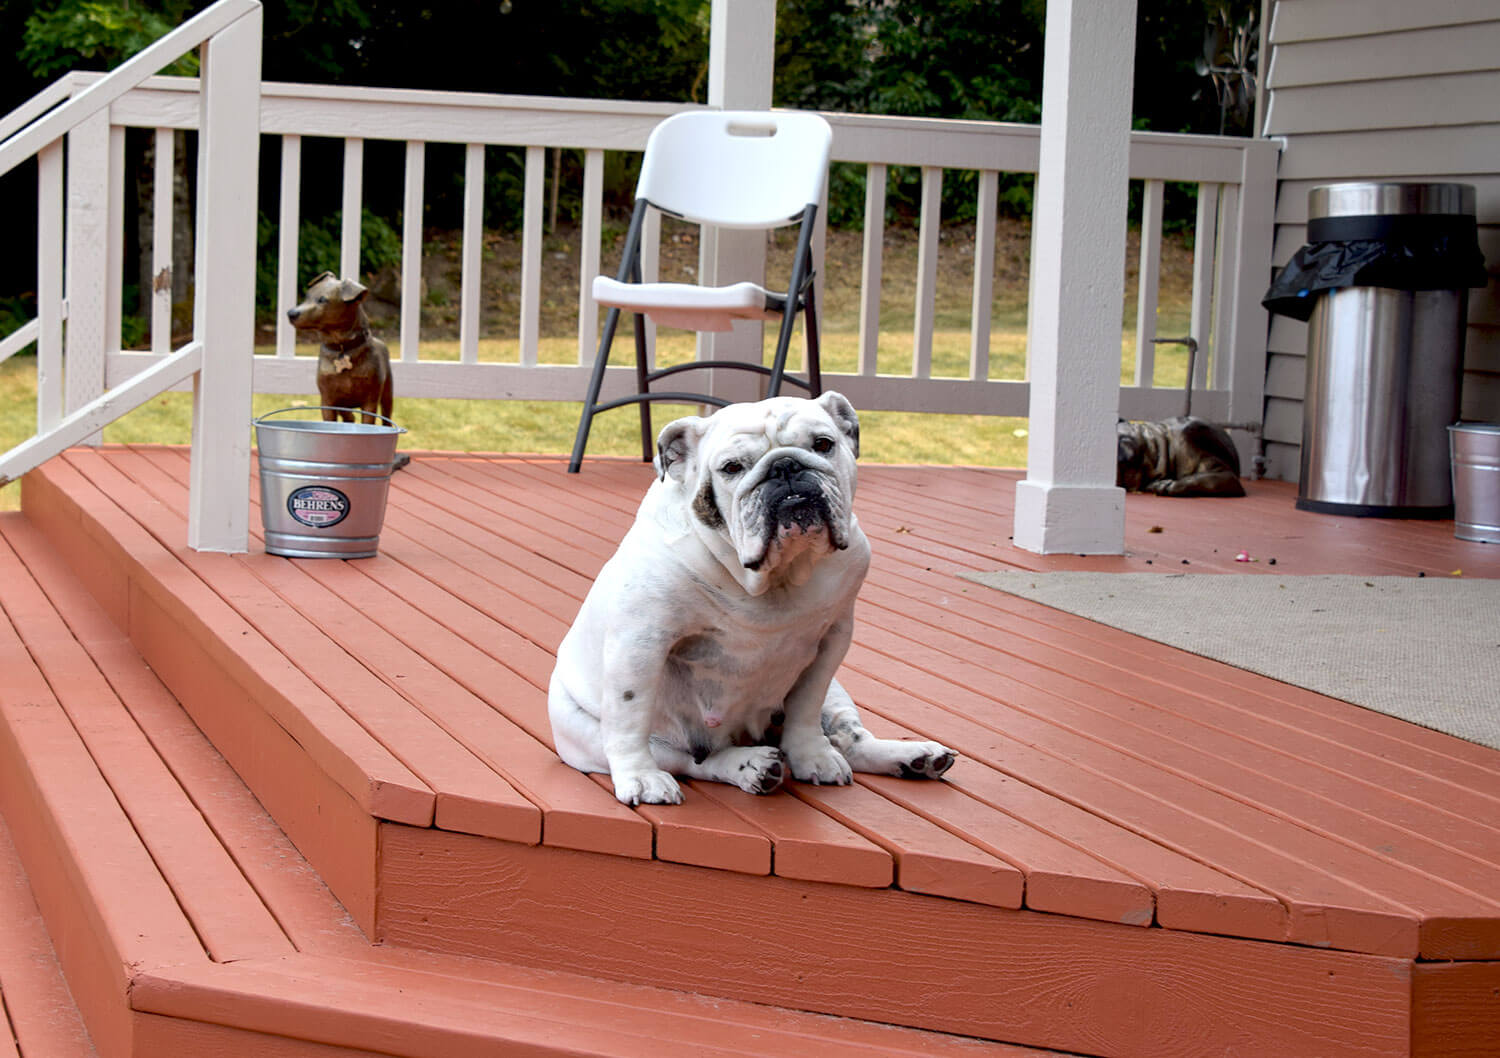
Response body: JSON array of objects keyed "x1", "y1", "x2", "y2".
[{"x1": 657, "y1": 392, "x2": 860, "y2": 579}]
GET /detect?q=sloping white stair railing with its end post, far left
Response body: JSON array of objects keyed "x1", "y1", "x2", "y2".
[{"x1": 0, "y1": 0, "x2": 261, "y2": 551}]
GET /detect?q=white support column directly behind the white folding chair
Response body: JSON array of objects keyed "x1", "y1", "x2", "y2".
[{"x1": 698, "y1": 0, "x2": 776, "y2": 401}]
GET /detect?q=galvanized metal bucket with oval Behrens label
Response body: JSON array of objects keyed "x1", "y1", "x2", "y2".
[{"x1": 255, "y1": 405, "x2": 407, "y2": 558}]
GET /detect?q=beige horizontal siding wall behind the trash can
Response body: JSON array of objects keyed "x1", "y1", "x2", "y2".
[{"x1": 1265, "y1": 0, "x2": 1500, "y2": 480}]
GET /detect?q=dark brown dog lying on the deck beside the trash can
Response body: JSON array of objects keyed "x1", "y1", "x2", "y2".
[{"x1": 1115, "y1": 416, "x2": 1245, "y2": 495}]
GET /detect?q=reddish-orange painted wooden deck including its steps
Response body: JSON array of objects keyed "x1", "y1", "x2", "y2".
[{"x1": 0, "y1": 447, "x2": 1500, "y2": 1058}]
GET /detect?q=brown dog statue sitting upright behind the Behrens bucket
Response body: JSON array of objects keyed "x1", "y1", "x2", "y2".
[{"x1": 287, "y1": 272, "x2": 395, "y2": 423}]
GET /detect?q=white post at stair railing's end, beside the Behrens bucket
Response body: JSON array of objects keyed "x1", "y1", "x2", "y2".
[{"x1": 188, "y1": 6, "x2": 261, "y2": 552}]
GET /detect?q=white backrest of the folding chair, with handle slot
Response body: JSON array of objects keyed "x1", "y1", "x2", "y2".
[{"x1": 636, "y1": 111, "x2": 833, "y2": 228}]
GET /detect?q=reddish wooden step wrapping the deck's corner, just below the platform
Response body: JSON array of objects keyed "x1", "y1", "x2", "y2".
[{"x1": 0, "y1": 513, "x2": 1040, "y2": 1058}]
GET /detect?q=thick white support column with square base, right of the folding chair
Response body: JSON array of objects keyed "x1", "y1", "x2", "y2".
[{"x1": 1014, "y1": 0, "x2": 1136, "y2": 554}]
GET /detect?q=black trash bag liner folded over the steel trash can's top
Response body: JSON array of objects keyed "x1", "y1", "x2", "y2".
[{"x1": 1260, "y1": 213, "x2": 1490, "y2": 321}]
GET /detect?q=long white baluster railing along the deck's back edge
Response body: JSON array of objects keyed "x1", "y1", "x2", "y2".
[{"x1": 0, "y1": 46, "x2": 1275, "y2": 549}]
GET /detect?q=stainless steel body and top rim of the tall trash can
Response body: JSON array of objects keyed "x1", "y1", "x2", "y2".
[{"x1": 1298, "y1": 183, "x2": 1475, "y2": 518}]
